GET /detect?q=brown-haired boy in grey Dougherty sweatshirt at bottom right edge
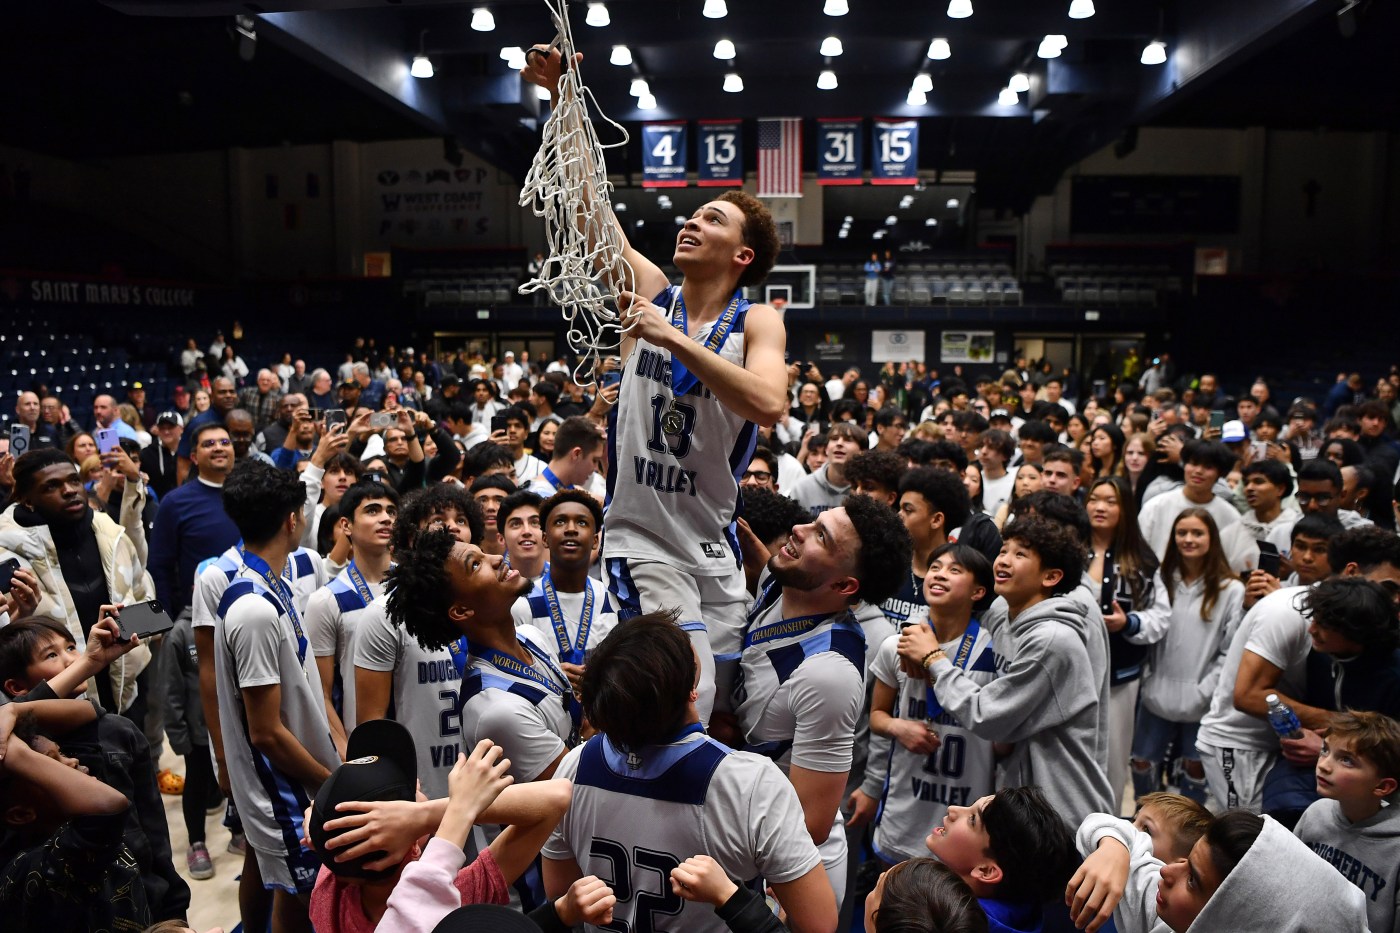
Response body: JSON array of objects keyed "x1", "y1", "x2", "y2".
[{"x1": 1294, "y1": 712, "x2": 1400, "y2": 930}]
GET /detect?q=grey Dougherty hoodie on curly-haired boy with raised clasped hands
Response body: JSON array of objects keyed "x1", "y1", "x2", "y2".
[{"x1": 930, "y1": 586, "x2": 1113, "y2": 825}]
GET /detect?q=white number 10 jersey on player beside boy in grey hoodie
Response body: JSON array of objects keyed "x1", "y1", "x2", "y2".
[{"x1": 871, "y1": 626, "x2": 997, "y2": 863}]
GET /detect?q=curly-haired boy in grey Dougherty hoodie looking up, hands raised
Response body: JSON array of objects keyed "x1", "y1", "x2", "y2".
[{"x1": 899, "y1": 516, "x2": 1114, "y2": 821}]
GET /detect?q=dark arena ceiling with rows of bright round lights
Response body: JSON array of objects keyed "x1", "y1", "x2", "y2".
[{"x1": 0, "y1": 0, "x2": 1400, "y2": 209}]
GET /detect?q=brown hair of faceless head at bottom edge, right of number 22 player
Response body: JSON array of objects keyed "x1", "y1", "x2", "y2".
[{"x1": 871, "y1": 857, "x2": 987, "y2": 933}]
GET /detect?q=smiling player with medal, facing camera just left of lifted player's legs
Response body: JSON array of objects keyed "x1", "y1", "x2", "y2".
[{"x1": 511, "y1": 489, "x2": 617, "y2": 689}]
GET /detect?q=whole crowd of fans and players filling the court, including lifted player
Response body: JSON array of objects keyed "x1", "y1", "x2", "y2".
[{"x1": 0, "y1": 48, "x2": 1400, "y2": 933}]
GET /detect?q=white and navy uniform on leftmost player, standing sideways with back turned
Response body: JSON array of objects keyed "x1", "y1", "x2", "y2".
[{"x1": 214, "y1": 551, "x2": 340, "y2": 887}]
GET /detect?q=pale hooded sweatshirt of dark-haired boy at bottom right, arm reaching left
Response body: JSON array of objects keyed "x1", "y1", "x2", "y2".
[{"x1": 1075, "y1": 813, "x2": 1366, "y2": 933}]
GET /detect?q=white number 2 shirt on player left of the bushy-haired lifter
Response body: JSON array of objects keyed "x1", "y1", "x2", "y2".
[{"x1": 347, "y1": 600, "x2": 470, "y2": 800}]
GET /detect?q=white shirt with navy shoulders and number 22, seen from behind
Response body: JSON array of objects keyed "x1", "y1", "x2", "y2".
[{"x1": 542, "y1": 731, "x2": 820, "y2": 933}]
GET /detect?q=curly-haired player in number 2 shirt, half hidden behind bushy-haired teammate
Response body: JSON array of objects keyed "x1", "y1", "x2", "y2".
[{"x1": 354, "y1": 483, "x2": 484, "y2": 800}]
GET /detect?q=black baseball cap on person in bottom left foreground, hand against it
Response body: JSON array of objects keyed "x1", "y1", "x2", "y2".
[{"x1": 307, "y1": 719, "x2": 419, "y2": 881}]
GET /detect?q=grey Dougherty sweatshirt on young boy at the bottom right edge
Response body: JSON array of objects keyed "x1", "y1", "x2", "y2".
[{"x1": 1294, "y1": 800, "x2": 1400, "y2": 932}]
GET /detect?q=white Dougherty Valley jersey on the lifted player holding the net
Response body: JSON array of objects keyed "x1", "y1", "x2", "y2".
[{"x1": 603, "y1": 286, "x2": 757, "y2": 576}]
